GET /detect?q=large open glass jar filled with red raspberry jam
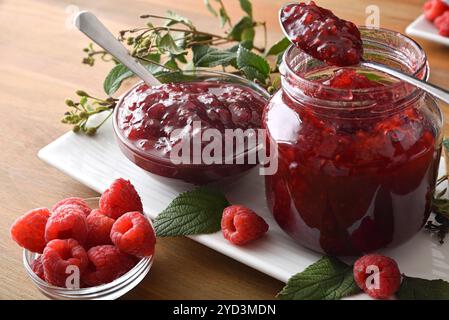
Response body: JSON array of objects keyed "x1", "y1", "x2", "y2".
[{"x1": 263, "y1": 29, "x2": 442, "y2": 256}]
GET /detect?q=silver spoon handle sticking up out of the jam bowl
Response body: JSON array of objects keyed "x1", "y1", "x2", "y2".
[{"x1": 75, "y1": 11, "x2": 161, "y2": 86}]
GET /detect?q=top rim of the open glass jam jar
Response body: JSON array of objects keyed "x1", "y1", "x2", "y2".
[{"x1": 281, "y1": 26, "x2": 430, "y2": 94}]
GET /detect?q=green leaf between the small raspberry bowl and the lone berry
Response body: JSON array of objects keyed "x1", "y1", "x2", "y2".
[{"x1": 154, "y1": 188, "x2": 229, "y2": 237}]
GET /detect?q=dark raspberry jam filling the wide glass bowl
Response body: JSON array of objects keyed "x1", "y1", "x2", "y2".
[{"x1": 115, "y1": 71, "x2": 268, "y2": 184}]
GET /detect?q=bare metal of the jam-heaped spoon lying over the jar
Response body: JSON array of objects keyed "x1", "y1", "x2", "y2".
[{"x1": 279, "y1": 3, "x2": 449, "y2": 103}]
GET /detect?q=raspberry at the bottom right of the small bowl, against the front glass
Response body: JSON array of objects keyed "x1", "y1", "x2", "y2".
[{"x1": 83, "y1": 245, "x2": 136, "y2": 287}]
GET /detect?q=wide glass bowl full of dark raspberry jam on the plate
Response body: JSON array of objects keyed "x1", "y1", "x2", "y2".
[{"x1": 113, "y1": 70, "x2": 269, "y2": 184}]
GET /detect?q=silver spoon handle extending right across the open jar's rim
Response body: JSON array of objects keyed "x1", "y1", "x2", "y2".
[{"x1": 362, "y1": 62, "x2": 449, "y2": 103}]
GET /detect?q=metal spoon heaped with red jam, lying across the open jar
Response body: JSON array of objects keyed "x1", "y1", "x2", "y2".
[{"x1": 279, "y1": 1, "x2": 449, "y2": 103}]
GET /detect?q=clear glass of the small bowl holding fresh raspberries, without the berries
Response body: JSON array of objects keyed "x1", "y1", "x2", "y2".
[{"x1": 23, "y1": 198, "x2": 154, "y2": 300}]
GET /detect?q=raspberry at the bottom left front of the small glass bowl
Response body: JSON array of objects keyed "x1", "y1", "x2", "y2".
[{"x1": 42, "y1": 239, "x2": 89, "y2": 288}]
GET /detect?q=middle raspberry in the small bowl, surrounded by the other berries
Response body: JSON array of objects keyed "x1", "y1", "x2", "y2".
[{"x1": 86, "y1": 210, "x2": 115, "y2": 248}]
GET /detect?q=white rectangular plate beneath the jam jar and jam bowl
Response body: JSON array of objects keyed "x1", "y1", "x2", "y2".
[{"x1": 39, "y1": 121, "x2": 449, "y2": 299}]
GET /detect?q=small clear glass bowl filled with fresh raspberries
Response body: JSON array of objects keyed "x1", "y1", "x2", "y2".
[{"x1": 11, "y1": 179, "x2": 156, "y2": 300}]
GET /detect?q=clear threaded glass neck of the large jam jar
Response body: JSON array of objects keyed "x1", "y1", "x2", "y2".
[{"x1": 280, "y1": 28, "x2": 429, "y2": 118}]
